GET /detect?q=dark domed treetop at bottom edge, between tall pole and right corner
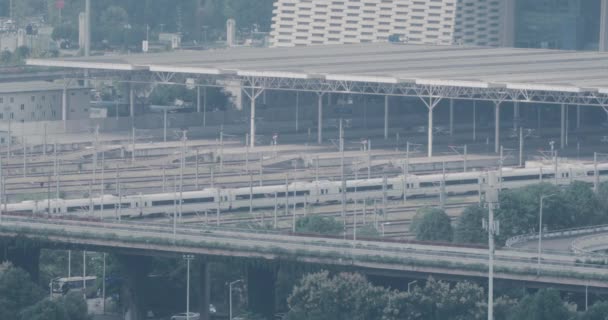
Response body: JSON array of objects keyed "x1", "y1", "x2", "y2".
[{"x1": 509, "y1": 289, "x2": 572, "y2": 320}]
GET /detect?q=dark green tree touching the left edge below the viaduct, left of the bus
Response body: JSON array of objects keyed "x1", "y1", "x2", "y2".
[{"x1": 0, "y1": 265, "x2": 45, "y2": 319}]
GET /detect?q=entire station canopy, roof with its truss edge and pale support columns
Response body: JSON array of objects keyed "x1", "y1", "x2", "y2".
[{"x1": 28, "y1": 43, "x2": 608, "y2": 156}]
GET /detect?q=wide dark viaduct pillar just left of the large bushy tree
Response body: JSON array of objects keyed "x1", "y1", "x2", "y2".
[{"x1": 247, "y1": 266, "x2": 276, "y2": 319}]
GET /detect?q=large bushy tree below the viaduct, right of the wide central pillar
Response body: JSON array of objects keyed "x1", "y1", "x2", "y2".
[{"x1": 286, "y1": 271, "x2": 389, "y2": 320}]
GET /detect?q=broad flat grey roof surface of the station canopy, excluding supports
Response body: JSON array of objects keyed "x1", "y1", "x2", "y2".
[{"x1": 28, "y1": 43, "x2": 608, "y2": 94}]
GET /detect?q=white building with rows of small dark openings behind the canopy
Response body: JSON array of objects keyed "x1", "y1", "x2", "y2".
[{"x1": 271, "y1": 0, "x2": 504, "y2": 47}]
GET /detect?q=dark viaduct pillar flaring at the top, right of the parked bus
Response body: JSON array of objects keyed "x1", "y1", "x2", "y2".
[{"x1": 117, "y1": 255, "x2": 153, "y2": 320}]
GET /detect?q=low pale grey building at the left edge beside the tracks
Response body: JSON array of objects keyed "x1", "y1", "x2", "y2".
[{"x1": 0, "y1": 81, "x2": 91, "y2": 122}]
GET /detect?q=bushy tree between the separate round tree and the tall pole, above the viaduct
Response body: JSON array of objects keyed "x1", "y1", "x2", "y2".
[{"x1": 454, "y1": 205, "x2": 488, "y2": 243}]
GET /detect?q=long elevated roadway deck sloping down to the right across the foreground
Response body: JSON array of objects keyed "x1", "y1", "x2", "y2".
[{"x1": 0, "y1": 216, "x2": 608, "y2": 290}]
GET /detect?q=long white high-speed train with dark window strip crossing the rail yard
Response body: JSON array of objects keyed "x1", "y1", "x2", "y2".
[{"x1": 2, "y1": 163, "x2": 608, "y2": 218}]
